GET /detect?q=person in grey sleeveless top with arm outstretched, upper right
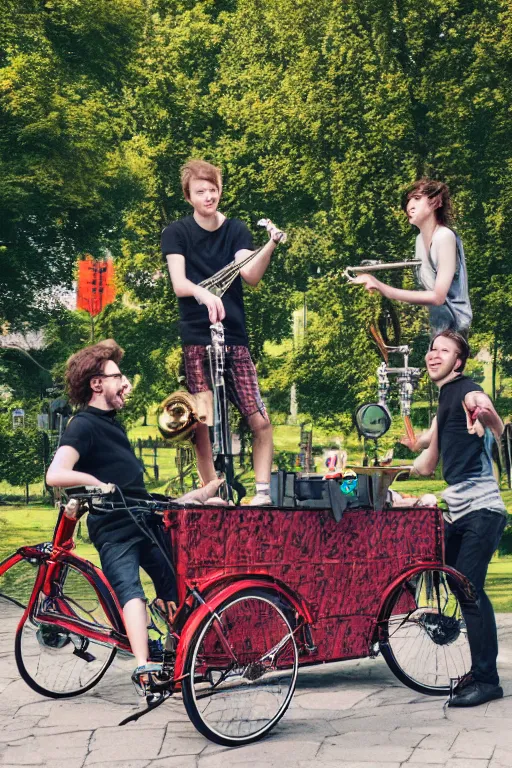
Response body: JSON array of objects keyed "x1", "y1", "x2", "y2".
[{"x1": 350, "y1": 178, "x2": 472, "y2": 336}]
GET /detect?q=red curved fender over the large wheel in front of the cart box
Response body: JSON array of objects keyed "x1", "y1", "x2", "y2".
[{"x1": 174, "y1": 577, "x2": 312, "y2": 681}]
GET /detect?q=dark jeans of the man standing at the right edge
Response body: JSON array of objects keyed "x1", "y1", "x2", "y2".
[{"x1": 444, "y1": 509, "x2": 507, "y2": 685}]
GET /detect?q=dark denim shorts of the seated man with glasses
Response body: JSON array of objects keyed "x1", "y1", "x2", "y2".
[{"x1": 98, "y1": 537, "x2": 176, "y2": 607}]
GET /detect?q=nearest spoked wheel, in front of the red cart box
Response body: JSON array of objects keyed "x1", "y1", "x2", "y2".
[{"x1": 182, "y1": 590, "x2": 298, "y2": 746}]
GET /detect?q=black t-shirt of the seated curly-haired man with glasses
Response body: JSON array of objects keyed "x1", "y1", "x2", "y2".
[{"x1": 60, "y1": 406, "x2": 151, "y2": 548}]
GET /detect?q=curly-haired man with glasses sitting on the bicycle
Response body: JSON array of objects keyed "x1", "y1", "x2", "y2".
[{"x1": 46, "y1": 339, "x2": 223, "y2": 689}]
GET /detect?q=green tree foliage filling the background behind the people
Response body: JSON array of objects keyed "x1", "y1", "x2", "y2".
[{"x1": 0, "y1": 0, "x2": 512, "y2": 416}]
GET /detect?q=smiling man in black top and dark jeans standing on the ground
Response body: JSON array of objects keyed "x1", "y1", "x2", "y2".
[{"x1": 403, "y1": 331, "x2": 507, "y2": 707}]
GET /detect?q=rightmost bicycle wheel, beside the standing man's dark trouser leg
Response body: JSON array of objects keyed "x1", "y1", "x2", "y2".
[{"x1": 379, "y1": 570, "x2": 471, "y2": 696}]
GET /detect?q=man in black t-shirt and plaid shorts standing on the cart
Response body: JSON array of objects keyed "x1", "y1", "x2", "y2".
[{"x1": 161, "y1": 160, "x2": 284, "y2": 506}]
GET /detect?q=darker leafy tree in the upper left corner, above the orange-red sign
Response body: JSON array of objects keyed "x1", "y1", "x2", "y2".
[{"x1": 0, "y1": 0, "x2": 148, "y2": 326}]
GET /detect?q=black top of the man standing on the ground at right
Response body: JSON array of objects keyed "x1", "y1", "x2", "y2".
[{"x1": 437, "y1": 376, "x2": 492, "y2": 485}]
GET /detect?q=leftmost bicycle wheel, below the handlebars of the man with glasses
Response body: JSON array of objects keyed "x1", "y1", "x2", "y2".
[{"x1": 14, "y1": 564, "x2": 116, "y2": 698}]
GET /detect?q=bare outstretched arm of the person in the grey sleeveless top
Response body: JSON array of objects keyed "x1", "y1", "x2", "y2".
[{"x1": 351, "y1": 230, "x2": 457, "y2": 307}]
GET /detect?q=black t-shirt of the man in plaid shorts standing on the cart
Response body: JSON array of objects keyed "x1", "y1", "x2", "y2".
[{"x1": 162, "y1": 216, "x2": 253, "y2": 346}]
